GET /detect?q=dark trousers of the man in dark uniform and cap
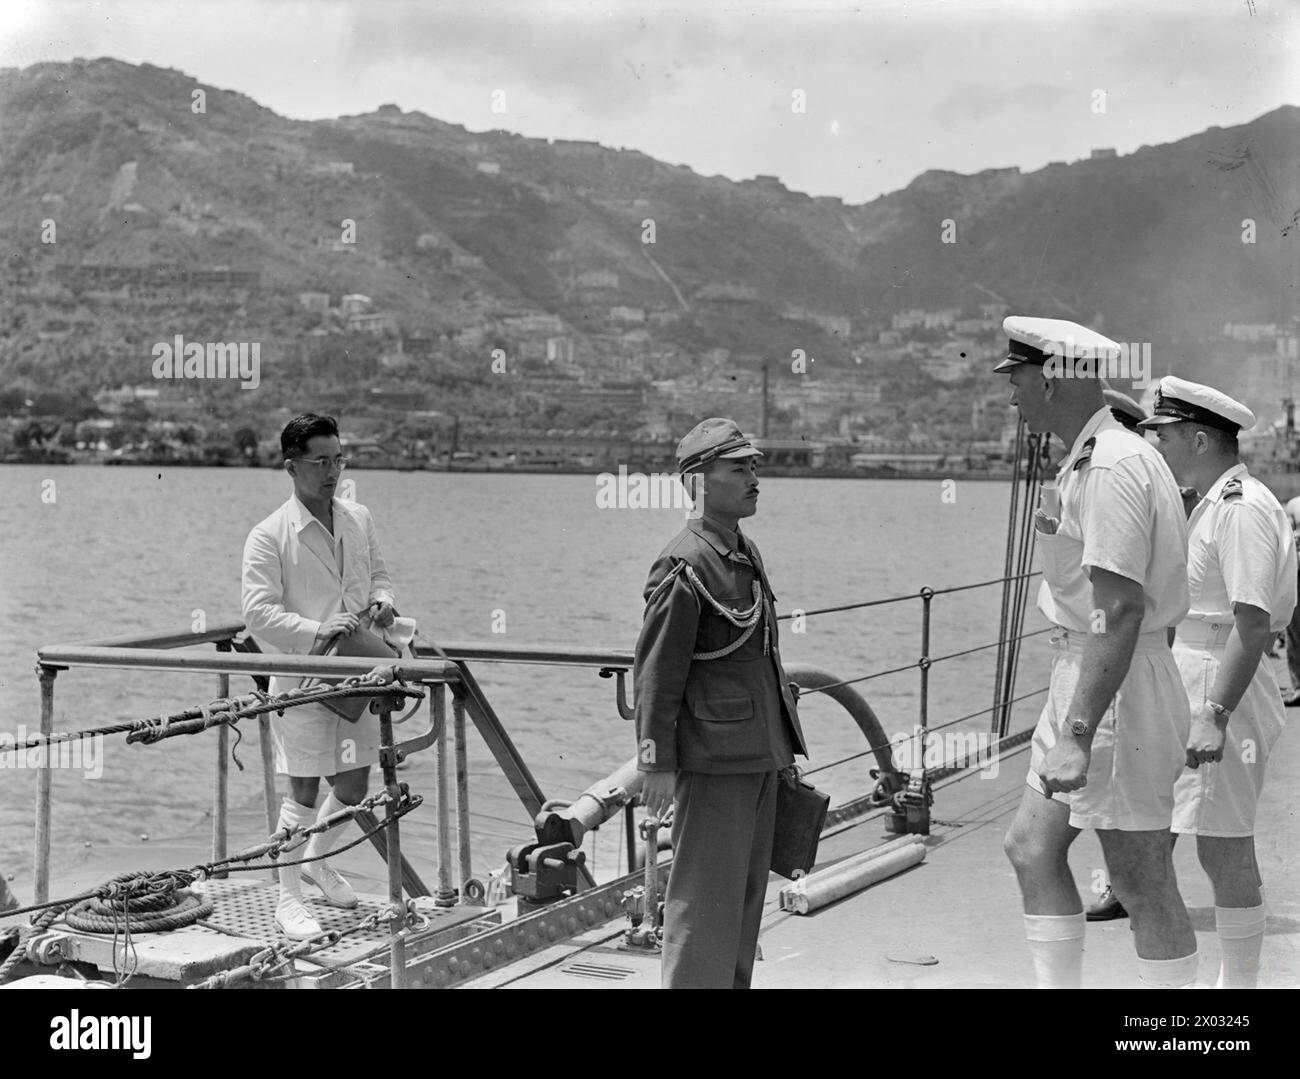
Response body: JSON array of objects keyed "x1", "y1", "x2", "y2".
[{"x1": 663, "y1": 771, "x2": 776, "y2": 989}]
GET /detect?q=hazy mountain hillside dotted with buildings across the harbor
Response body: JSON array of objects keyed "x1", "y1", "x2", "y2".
[{"x1": 0, "y1": 60, "x2": 1300, "y2": 439}]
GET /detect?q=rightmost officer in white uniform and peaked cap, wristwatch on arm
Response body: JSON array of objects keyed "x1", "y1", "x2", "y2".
[{"x1": 1143, "y1": 377, "x2": 1296, "y2": 989}]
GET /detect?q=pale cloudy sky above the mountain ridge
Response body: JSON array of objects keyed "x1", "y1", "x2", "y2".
[{"x1": 0, "y1": 0, "x2": 1300, "y2": 203}]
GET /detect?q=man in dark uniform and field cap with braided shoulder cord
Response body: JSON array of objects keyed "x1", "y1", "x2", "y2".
[{"x1": 633, "y1": 419, "x2": 807, "y2": 989}]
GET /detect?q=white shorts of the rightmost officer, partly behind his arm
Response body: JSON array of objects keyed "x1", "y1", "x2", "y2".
[{"x1": 1174, "y1": 623, "x2": 1286, "y2": 837}]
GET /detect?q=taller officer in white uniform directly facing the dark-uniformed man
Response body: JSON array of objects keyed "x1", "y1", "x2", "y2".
[{"x1": 996, "y1": 316, "x2": 1197, "y2": 988}]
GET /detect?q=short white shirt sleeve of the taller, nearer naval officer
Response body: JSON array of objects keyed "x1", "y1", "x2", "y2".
[{"x1": 1079, "y1": 458, "x2": 1154, "y2": 585}]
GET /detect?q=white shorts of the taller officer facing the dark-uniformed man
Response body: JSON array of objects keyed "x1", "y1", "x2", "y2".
[{"x1": 1024, "y1": 629, "x2": 1192, "y2": 832}]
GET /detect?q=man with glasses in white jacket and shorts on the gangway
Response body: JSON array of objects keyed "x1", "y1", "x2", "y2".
[{"x1": 243, "y1": 412, "x2": 395, "y2": 940}]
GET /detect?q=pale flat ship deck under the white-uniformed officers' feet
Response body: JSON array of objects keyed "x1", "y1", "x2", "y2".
[{"x1": 467, "y1": 729, "x2": 1300, "y2": 989}]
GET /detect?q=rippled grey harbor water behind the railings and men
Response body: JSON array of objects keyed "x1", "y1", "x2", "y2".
[{"x1": 0, "y1": 465, "x2": 1048, "y2": 893}]
